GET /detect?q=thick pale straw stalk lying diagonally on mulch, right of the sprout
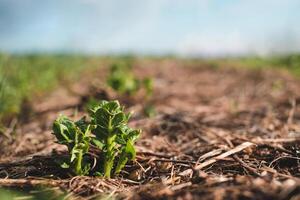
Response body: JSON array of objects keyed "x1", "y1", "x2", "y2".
[{"x1": 194, "y1": 142, "x2": 254, "y2": 170}]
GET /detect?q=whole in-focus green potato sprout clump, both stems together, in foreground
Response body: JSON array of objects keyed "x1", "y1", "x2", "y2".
[{"x1": 53, "y1": 101, "x2": 141, "y2": 178}]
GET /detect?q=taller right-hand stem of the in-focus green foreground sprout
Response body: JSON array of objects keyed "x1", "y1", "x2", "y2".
[{"x1": 91, "y1": 101, "x2": 141, "y2": 178}]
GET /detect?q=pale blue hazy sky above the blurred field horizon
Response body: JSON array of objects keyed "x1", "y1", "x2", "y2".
[{"x1": 0, "y1": 0, "x2": 300, "y2": 56}]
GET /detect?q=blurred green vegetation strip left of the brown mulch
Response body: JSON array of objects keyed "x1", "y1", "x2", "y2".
[{"x1": 0, "y1": 54, "x2": 100, "y2": 121}]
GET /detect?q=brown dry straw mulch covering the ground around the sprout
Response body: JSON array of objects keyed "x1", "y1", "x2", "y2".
[{"x1": 0, "y1": 60, "x2": 300, "y2": 200}]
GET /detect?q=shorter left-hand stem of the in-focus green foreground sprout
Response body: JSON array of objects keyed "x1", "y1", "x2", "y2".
[{"x1": 53, "y1": 116, "x2": 91, "y2": 175}]
